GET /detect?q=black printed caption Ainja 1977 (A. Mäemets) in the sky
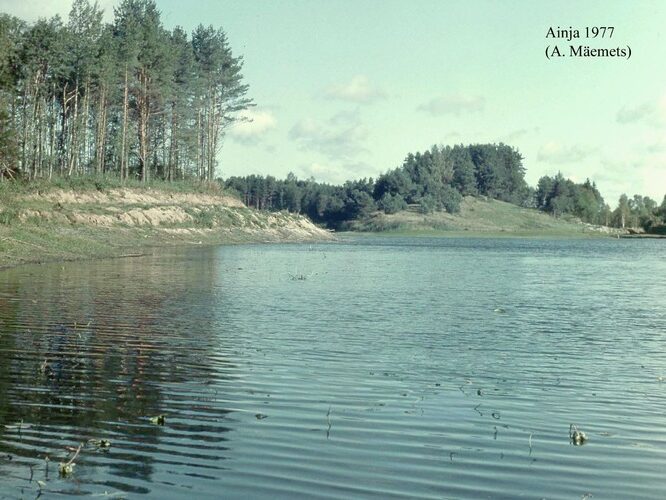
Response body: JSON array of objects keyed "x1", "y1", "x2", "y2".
[{"x1": 545, "y1": 26, "x2": 631, "y2": 59}]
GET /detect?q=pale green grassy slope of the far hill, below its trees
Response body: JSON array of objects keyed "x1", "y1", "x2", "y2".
[{"x1": 348, "y1": 196, "x2": 624, "y2": 237}]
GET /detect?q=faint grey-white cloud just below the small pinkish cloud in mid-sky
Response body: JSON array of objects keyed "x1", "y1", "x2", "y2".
[{"x1": 289, "y1": 112, "x2": 368, "y2": 159}]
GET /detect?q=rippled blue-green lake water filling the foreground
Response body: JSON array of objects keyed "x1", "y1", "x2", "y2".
[{"x1": 0, "y1": 238, "x2": 666, "y2": 499}]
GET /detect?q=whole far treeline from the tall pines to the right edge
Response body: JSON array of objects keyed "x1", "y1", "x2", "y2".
[{"x1": 224, "y1": 144, "x2": 666, "y2": 230}]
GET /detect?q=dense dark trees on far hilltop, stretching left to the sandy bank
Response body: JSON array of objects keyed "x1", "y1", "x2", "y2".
[{"x1": 225, "y1": 144, "x2": 533, "y2": 227}]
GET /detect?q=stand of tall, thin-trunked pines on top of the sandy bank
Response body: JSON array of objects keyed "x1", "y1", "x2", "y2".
[{"x1": 0, "y1": 0, "x2": 252, "y2": 181}]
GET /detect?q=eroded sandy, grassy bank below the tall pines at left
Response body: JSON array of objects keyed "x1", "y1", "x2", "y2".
[{"x1": 0, "y1": 178, "x2": 331, "y2": 267}]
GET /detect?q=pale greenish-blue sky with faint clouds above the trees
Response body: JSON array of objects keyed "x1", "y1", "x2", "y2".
[{"x1": 0, "y1": 0, "x2": 666, "y2": 206}]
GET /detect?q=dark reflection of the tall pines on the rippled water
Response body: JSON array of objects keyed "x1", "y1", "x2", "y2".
[{"x1": 0, "y1": 255, "x2": 234, "y2": 494}]
